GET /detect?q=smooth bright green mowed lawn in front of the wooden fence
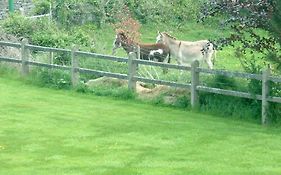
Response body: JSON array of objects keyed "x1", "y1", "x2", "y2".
[{"x1": 0, "y1": 76, "x2": 281, "y2": 175}]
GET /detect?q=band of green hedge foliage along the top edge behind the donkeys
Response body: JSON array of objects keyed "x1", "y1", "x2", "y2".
[{"x1": 35, "y1": 0, "x2": 203, "y2": 27}]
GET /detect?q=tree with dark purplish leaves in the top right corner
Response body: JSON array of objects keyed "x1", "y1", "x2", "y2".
[{"x1": 199, "y1": 0, "x2": 281, "y2": 72}]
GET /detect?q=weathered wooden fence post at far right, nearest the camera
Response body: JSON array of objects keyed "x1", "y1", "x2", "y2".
[{"x1": 261, "y1": 68, "x2": 270, "y2": 125}]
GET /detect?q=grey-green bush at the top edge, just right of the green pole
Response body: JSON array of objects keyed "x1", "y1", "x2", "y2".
[{"x1": 49, "y1": 0, "x2": 122, "y2": 27}]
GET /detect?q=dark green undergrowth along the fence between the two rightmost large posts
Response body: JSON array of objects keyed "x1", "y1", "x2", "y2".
[{"x1": 199, "y1": 75, "x2": 261, "y2": 122}]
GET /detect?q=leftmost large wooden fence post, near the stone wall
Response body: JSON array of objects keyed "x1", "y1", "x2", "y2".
[{"x1": 21, "y1": 39, "x2": 29, "y2": 76}]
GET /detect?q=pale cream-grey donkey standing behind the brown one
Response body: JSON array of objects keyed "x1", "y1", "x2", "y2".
[{"x1": 156, "y1": 32, "x2": 216, "y2": 69}]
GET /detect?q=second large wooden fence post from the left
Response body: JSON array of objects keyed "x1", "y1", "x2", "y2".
[{"x1": 71, "y1": 46, "x2": 80, "y2": 87}]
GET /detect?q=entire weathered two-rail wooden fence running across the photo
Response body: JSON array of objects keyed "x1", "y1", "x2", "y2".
[{"x1": 0, "y1": 40, "x2": 281, "y2": 124}]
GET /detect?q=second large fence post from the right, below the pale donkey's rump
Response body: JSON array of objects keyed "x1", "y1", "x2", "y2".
[{"x1": 190, "y1": 60, "x2": 199, "y2": 108}]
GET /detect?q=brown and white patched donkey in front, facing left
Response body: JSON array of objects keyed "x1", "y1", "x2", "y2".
[{"x1": 112, "y1": 31, "x2": 170, "y2": 63}]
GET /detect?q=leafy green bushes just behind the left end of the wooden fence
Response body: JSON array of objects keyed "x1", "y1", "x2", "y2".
[{"x1": 3, "y1": 14, "x2": 94, "y2": 65}]
